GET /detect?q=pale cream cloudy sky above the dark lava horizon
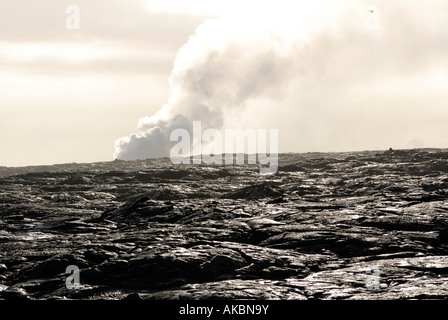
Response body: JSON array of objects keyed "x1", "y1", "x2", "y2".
[{"x1": 0, "y1": 0, "x2": 448, "y2": 166}]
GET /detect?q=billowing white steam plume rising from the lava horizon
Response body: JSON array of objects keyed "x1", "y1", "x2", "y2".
[{"x1": 114, "y1": 0, "x2": 447, "y2": 160}]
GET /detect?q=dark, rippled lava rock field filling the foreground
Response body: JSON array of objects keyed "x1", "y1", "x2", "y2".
[{"x1": 0, "y1": 149, "x2": 448, "y2": 299}]
